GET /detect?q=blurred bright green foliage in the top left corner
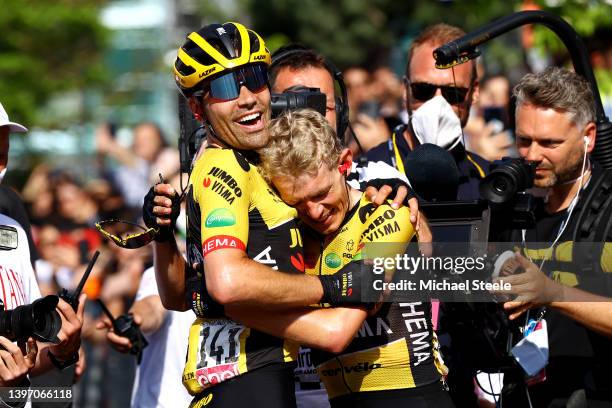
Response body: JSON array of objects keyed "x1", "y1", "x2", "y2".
[{"x1": 0, "y1": 0, "x2": 106, "y2": 125}]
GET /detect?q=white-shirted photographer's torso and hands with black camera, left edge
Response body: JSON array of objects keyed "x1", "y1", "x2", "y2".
[{"x1": 0, "y1": 215, "x2": 85, "y2": 406}]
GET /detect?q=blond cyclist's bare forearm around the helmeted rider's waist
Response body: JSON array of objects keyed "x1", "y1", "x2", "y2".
[{"x1": 225, "y1": 306, "x2": 367, "y2": 353}]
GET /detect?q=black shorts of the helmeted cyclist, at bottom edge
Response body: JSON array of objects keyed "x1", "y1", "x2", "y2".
[{"x1": 189, "y1": 363, "x2": 296, "y2": 408}]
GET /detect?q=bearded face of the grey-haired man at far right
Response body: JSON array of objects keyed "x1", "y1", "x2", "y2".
[{"x1": 516, "y1": 104, "x2": 595, "y2": 196}]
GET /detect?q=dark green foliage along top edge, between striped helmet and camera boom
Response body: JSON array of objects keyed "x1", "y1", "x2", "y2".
[{"x1": 192, "y1": 0, "x2": 514, "y2": 67}]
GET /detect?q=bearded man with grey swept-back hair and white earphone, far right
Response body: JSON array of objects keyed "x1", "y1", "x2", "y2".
[{"x1": 494, "y1": 68, "x2": 612, "y2": 407}]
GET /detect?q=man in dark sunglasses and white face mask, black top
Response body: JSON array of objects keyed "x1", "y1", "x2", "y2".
[{"x1": 367, "y1": 24, "x2": 488, "y2": 200}]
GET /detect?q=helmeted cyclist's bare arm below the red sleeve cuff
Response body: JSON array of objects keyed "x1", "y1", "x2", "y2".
[{"x1": 204, "y1": 249, "x2": 323, "y2": 309}]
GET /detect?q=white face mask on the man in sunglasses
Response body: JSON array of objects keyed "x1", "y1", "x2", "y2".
[{"x1": 411, "y1": 95, "x2": 462, "y2": 150}]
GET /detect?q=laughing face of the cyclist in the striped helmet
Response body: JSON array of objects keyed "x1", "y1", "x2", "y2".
[{"x1": 189, "y1": 81, "x2": 271, "y2": 150}]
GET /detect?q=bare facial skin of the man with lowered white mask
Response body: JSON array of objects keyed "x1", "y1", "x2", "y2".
[{"x1": 405, "y1": 43, "x2": 478, "y2": 127}]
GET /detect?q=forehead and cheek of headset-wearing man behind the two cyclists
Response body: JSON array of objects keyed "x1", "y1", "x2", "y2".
[{"x1": 272, "y1": 67, "x2": 336, "y2": 129}]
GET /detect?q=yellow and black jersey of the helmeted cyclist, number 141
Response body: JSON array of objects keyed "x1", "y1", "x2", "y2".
[{"x1": 183, "y1": 148, "x2": 304, "y2": 395}]
